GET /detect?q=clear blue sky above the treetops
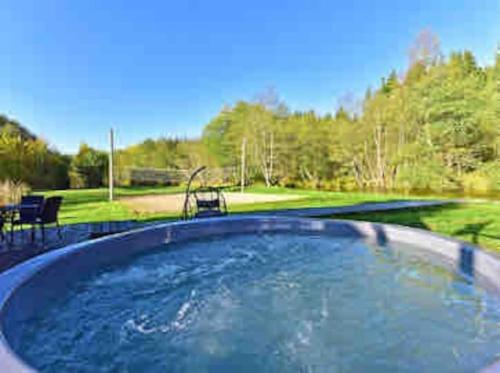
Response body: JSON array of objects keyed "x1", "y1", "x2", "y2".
[{"x1": 0, "y1": 0, "x2": 500, "y2": 152}]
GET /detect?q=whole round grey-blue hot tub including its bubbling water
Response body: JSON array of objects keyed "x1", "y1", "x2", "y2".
[{"x1": 0, "y1": 216, "x2": 500, "y2": 372}]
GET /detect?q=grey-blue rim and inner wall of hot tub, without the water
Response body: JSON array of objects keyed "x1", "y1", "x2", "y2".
[{"x1": 0, "y1": 216, "x2": 500, "y2": 372}]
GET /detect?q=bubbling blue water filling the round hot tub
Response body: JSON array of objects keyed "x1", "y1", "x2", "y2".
[{"x1": 7, "y1": 233, "x2": 500, "y2": 372}]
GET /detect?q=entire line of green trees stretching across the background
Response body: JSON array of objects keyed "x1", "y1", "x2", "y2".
[{"x1": 0, "y1": 31, "x2": 500, "y2": 196}]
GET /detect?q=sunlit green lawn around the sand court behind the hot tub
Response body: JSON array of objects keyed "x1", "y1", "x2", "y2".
[{"x1": 38, "y1": 186, "x2": 500, "y2": 251}]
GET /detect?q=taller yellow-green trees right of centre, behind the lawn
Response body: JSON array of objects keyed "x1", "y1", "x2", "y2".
[{"x1": 202, "y1": 32, "x2": 500, "y2": 192}]
